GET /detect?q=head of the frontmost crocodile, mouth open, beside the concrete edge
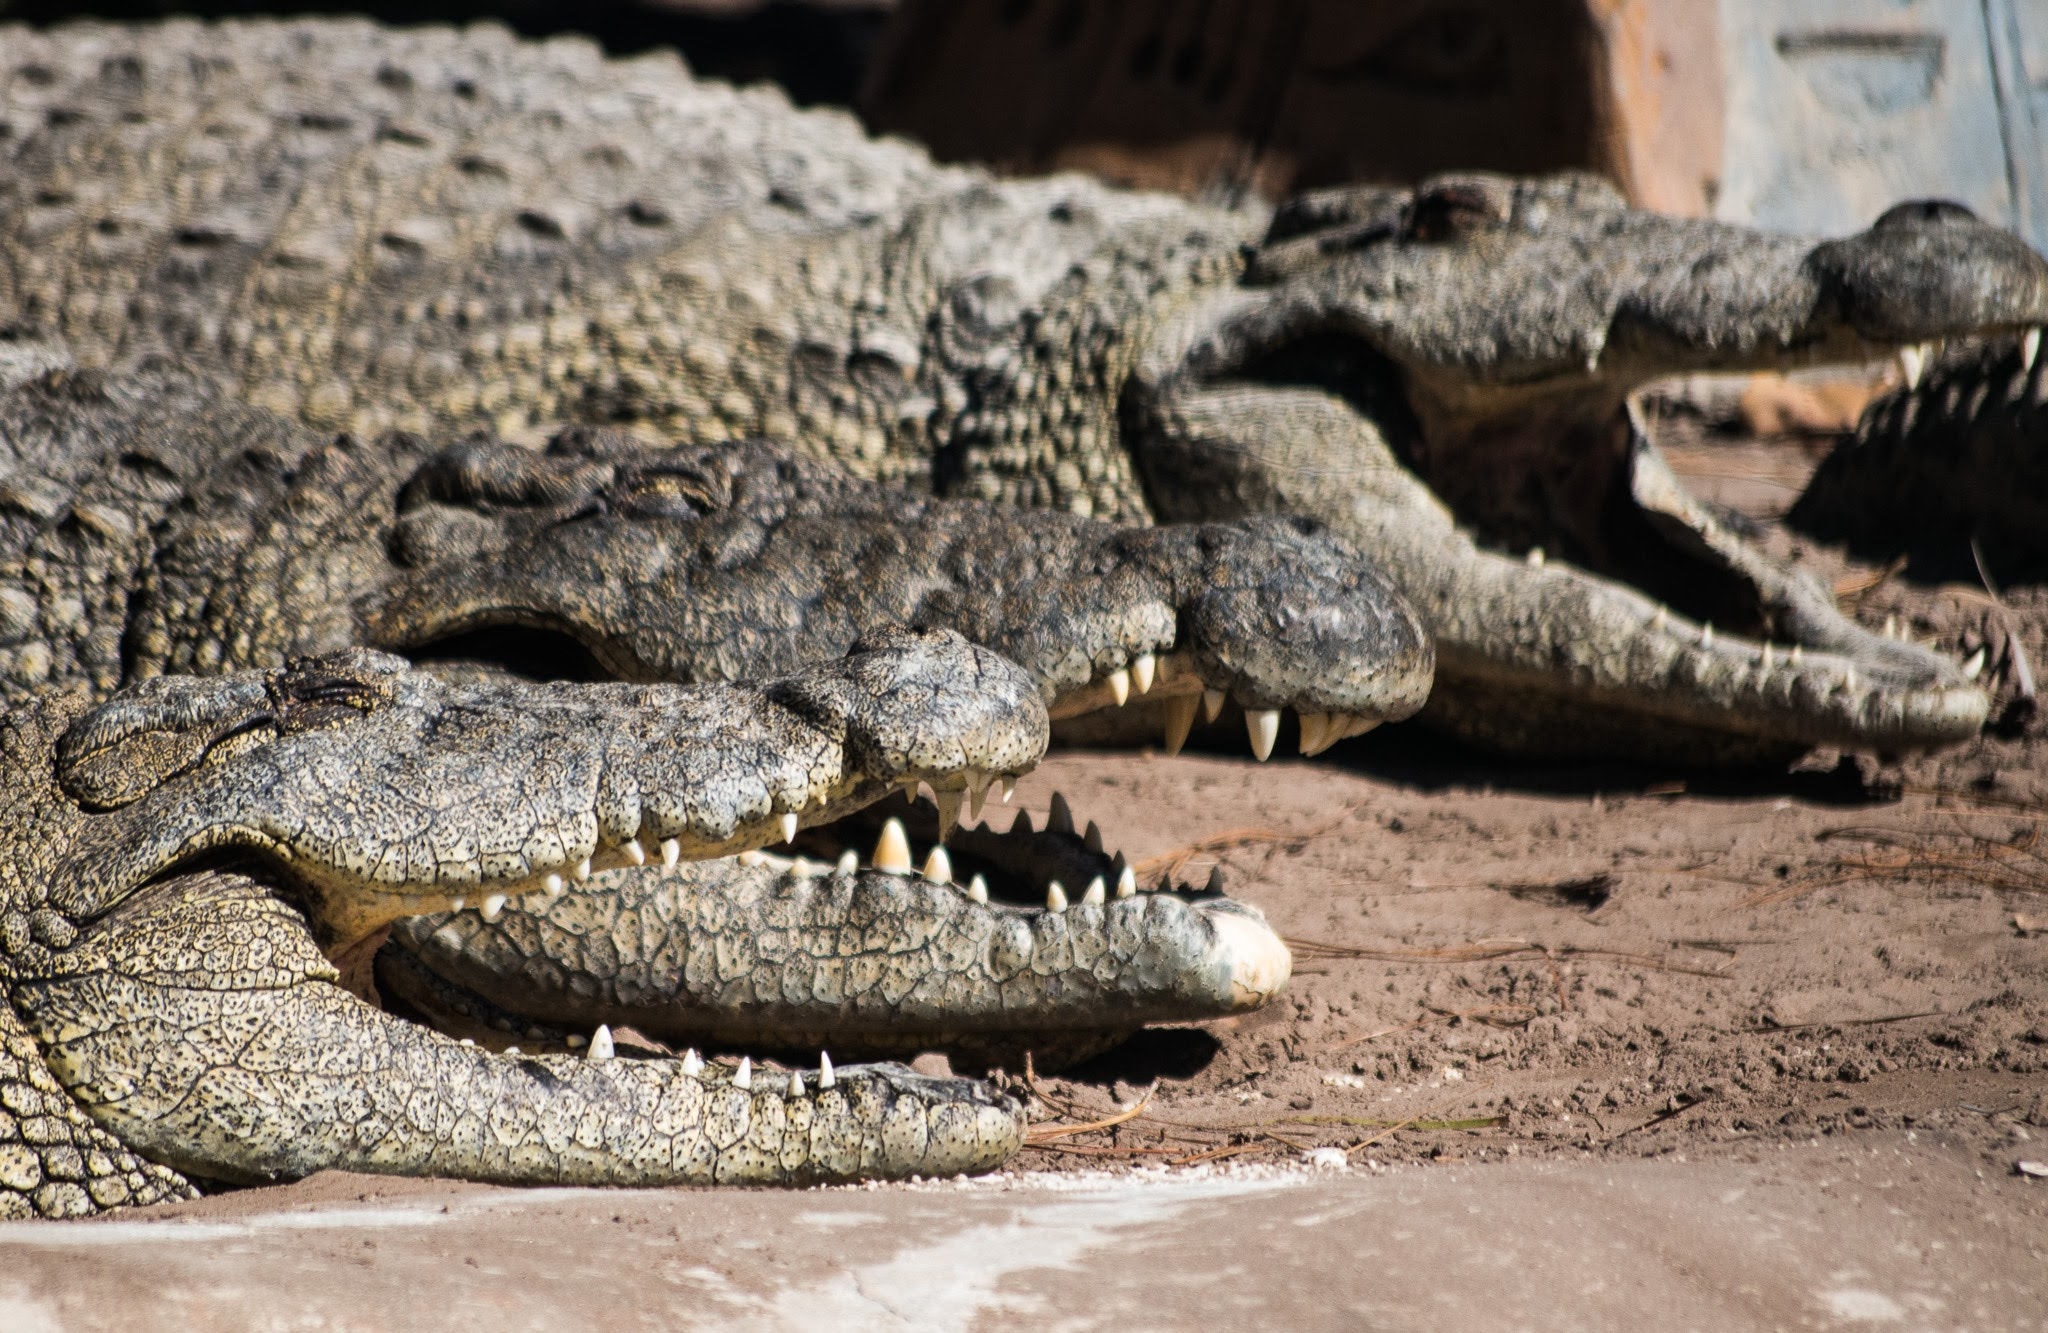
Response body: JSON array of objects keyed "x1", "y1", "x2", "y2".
[{"x1": 0, "y1": 631, "x2": 1047, "y2": 1212}]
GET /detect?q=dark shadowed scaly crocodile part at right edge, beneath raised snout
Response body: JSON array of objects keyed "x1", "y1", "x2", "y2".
[{"x1": 1786, "y1": 334, "x2": 2048, "y2": 586}]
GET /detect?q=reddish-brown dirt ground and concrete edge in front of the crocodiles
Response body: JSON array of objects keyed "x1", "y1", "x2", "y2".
[{"x1": 0, "y1": 427, "x2": 2048, "y2": 1329}]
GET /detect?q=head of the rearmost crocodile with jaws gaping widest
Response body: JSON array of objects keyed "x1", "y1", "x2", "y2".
[{"x1": 1124, "y1": 176, "x2": 2048, "y2": 762}]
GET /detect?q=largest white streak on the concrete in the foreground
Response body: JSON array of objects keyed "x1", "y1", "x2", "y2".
[{"x1": 758, "y1": 1175, "x2": 1303, "y2": 1329}]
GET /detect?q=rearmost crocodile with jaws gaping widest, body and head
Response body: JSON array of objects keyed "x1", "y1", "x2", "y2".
[{"x1": 0, "y1": 20, "x2": 2048, "y2": 764}]
